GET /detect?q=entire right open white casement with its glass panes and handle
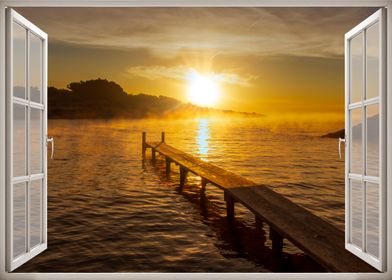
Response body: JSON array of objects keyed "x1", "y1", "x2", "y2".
[{"x1": 339, "y1": 9, "x2": 387, "y2": 271}]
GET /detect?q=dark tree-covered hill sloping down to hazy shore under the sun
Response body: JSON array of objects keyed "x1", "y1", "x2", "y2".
[{"x1": 48, "y1": 79, "x2": 263, "y2": 119}]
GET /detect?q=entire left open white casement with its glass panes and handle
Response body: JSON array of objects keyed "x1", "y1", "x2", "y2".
[{"x1": 6, "y1": 9, "x2": 49, "y2": 271}]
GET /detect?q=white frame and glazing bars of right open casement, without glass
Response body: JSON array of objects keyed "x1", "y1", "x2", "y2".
[{"x1": 344, "y1": 9, "x2": 387, "y2": 271}]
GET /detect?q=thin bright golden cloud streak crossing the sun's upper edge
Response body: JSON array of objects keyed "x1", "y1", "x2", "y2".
[{"x1": 127, "y1": 65, "x2": 258, "y2": 87}]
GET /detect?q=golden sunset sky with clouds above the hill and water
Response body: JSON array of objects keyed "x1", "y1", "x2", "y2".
[{"x1": 17, "y1": 8, "x2": 376, "y2": 120}]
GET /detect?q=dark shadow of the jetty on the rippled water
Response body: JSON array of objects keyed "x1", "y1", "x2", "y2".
[{"x1": 142, "y1": 156, "x2": 325, "y2": 272}]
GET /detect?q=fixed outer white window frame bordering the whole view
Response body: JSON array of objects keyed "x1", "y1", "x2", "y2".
[{"x1": 0, "y1": 0, "x2": 392, "y2": 280}]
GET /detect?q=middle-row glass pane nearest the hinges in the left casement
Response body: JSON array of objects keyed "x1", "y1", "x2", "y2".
[{"x1": 12, "y1": 104, "x2": 27, "y2": 177}]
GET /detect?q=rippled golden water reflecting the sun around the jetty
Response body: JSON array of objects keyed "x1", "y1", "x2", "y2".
[{"x1": 18, "y1": 118, "x2": 344, "y2": 272}]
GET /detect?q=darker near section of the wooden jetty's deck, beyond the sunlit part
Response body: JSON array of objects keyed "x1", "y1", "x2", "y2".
[{"x1": 228, "y1": 185, "x2": 376, "y2": 272}]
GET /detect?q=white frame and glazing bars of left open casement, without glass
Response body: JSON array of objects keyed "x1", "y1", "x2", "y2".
[{"x1": 6, "y1": 9, "x2": 48, "y2": 271}]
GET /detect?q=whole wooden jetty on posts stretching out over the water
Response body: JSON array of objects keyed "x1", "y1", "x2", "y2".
[{"x1": 142, "y1": 132, "x2": 377, "y2": 272}]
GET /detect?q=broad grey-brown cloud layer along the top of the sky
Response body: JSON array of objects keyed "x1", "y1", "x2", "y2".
[{"x1": 17, "y1": 8, "x2": 374, "y2": 57}]
